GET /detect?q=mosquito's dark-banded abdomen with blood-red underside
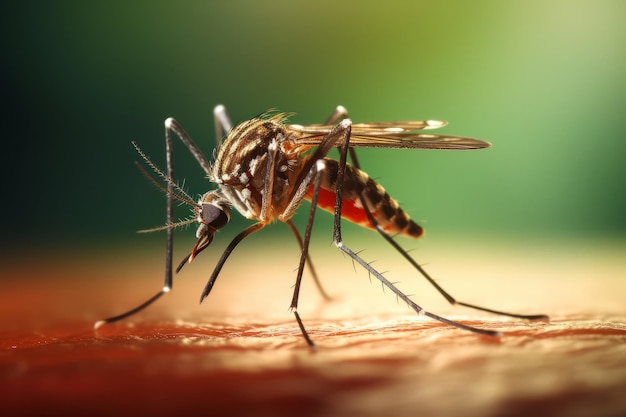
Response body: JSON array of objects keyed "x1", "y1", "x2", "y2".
[{"x1": 306, "y1": 158, "x2": 424, "y2": 239}]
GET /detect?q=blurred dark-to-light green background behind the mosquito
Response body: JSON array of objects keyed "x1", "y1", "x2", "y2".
[{"x1": 0, "y1": 0, "x2": 626, "y2": 250}]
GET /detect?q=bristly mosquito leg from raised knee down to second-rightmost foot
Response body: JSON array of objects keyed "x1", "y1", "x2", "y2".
[{"x1": 333, "y1": 119, "x2": 501, "y2": 336}]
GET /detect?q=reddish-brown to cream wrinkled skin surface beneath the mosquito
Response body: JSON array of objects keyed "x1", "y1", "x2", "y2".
[{"x1": 0, "y1": 240, "x2": 626, "y2": 416}]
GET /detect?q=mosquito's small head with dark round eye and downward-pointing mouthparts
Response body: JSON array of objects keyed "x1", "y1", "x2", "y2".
[{"x1": 188, "y1": 190, "x2": 230, "y2": 262}]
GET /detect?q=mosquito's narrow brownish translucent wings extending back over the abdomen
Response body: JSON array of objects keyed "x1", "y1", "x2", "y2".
[{"x1": 288, "y1": 120, "x2": 491, "y2": 150}]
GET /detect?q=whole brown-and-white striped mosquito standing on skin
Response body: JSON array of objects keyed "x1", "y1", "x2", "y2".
[{"x1": 95, "y1": 105, "x2": 548, "y2": 347}]
